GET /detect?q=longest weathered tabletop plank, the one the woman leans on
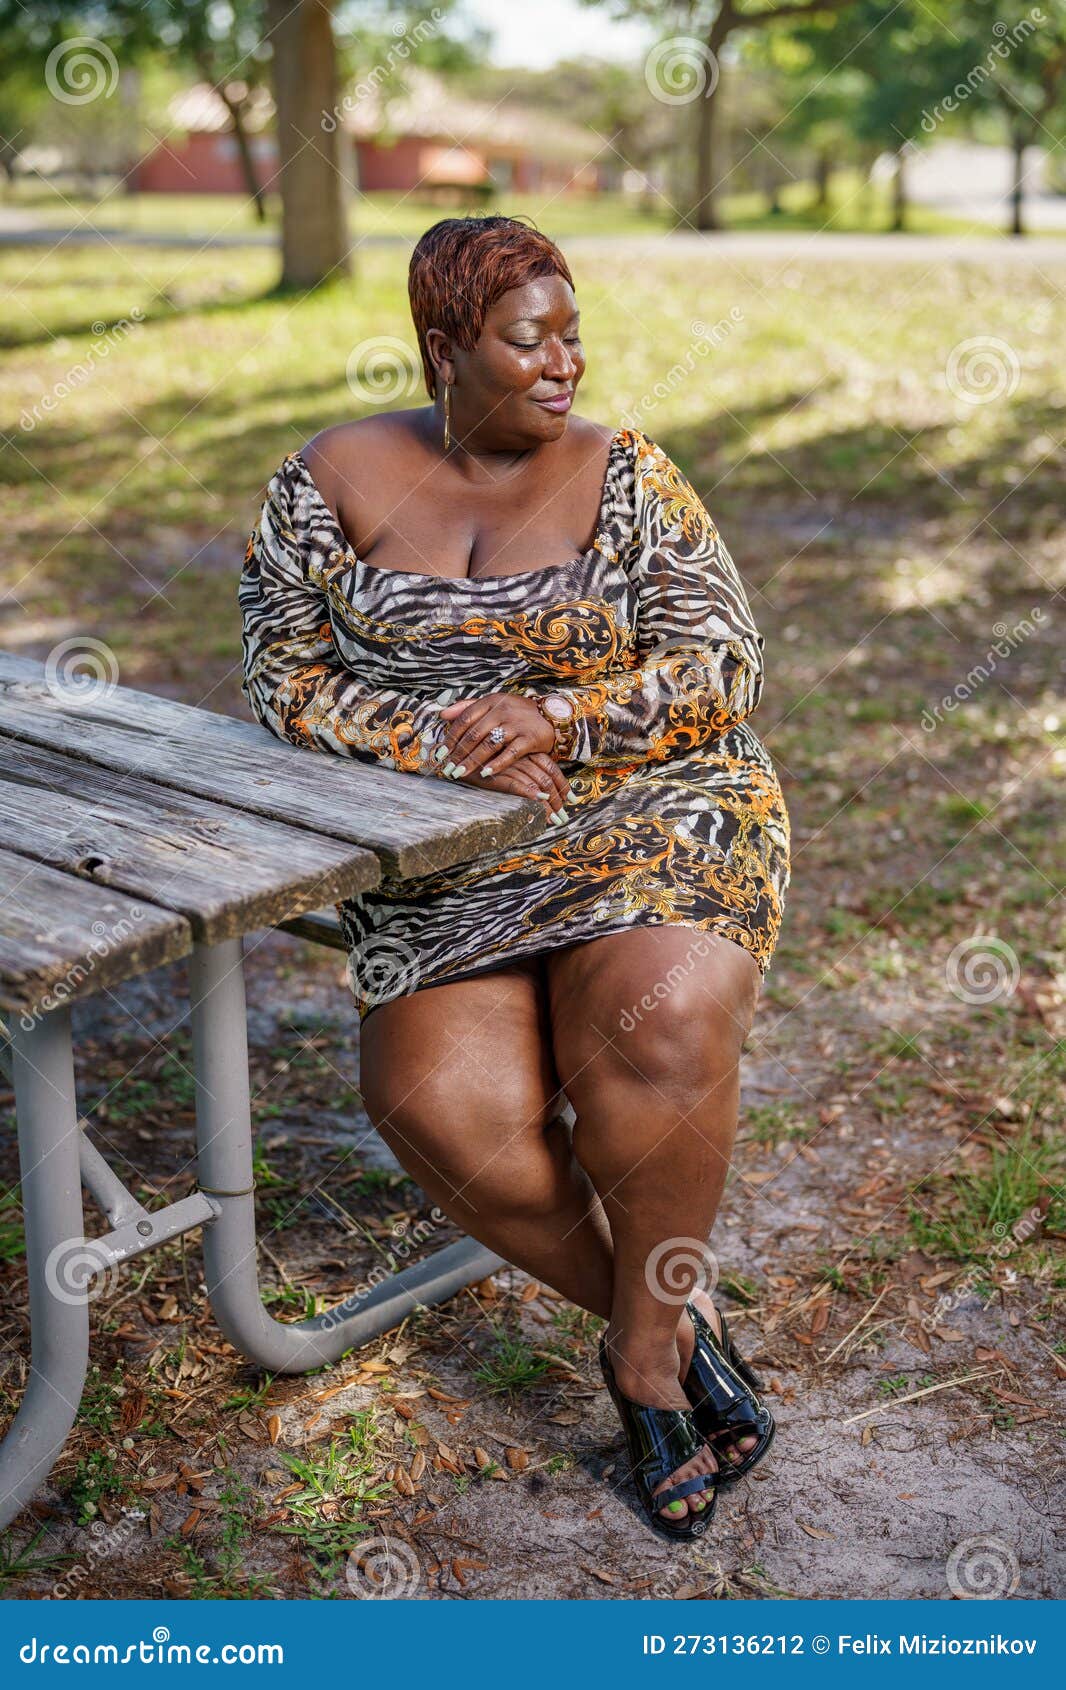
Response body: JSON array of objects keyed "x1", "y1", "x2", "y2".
[{"x1": 0, "y1": 652, "x2": 544, "y2": 879}]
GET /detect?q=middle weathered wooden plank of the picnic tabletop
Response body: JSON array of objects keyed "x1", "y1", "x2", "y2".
[{"x1": 0, "y1": 737, "x2": 380, "y2": 945}]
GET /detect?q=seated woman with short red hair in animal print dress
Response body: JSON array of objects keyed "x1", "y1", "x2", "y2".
[{"x1": 240, "y1": 216, "x2": 789, "y2": 1538}]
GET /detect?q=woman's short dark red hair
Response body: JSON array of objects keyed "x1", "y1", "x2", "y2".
[{"x1": 407, "y1": 216, "x2": 574, "y2": 399}]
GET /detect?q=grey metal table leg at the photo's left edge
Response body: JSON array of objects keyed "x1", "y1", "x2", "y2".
[{"x1": 0, "y1": 1009, "x2": 90, "y2": 1526}]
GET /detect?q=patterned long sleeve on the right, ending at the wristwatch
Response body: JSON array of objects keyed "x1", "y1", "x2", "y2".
[{"x1": 537, "y1": 431, "x2": 764, "y2": 762}]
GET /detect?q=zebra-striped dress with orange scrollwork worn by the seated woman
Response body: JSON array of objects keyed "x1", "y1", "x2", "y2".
[{"x1": 238, "y1": 429, "x2": 789, "y2": 1017}]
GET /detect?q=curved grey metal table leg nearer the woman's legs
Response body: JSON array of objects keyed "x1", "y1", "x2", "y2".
[{"x1": 189, "y1": 938, "x2": 503, "y2": 1372}]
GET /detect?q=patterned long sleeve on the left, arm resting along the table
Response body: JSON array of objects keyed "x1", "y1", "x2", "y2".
[{"x1": 238, "y1": 458, "x2": 439, "y2": 774}]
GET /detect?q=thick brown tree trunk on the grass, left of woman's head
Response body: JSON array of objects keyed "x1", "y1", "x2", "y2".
[{"x1": 267, "y1": 0, "x2": 351, "y2": 287}]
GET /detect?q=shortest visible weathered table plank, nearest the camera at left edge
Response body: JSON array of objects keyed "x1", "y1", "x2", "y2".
[{"x1": 0, "y1": 850, "x2": 193, "y2": 1017}]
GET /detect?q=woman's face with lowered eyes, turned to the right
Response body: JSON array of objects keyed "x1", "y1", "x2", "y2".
[{"x1": 432, "y1": 275, "x2": 585, "y2": 450}]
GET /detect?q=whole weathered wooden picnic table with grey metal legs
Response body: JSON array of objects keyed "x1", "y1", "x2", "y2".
[{"x1": 0, "y1": 652, "x2": 541, "y2": 1524}]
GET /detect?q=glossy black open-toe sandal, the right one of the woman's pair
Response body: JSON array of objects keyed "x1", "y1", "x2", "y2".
[{"x1": 684, "y1": 1303, "x2": 777, "y2": 1491}]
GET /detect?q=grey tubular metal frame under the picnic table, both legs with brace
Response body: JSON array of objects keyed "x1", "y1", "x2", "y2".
[{"x1": 0, "y1": 938, "x2": 503, "y2": 1526}]
